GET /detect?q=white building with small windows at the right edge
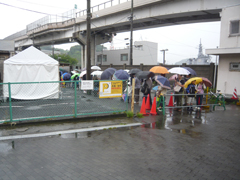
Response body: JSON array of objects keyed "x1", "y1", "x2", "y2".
[{"x1": 206, "y1": 5, "x2": 240, "y2": 97}]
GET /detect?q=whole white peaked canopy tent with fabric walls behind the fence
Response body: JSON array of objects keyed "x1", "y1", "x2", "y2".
[{"x1": 3, "y1": 46, "x2": 59, "y2": 100}]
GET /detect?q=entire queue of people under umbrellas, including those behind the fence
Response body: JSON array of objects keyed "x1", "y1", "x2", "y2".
[{"x1": 61, "y1": 67, "x2": 206, "y2": 111}]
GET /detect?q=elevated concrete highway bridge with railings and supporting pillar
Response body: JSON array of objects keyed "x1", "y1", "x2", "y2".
[{"x1": 5, "y1": 0, "x2": 240, "y2": 67}]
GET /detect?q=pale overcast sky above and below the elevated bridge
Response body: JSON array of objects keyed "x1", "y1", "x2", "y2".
[{"x1": 0, "y1": 0, "x2": 220, "y2": 64}]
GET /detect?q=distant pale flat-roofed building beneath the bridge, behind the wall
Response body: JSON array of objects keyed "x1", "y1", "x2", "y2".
[{"x1": 96, "y1": 41, "x2": 158, "y2": 65}]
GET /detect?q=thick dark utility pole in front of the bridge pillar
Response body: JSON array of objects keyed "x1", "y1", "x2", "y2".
[{"x1": 87, "y1": 0, "x2": 92, "y2": 80}]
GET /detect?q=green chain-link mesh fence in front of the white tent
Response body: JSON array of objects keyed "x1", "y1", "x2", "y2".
[{"x1": 0, "y1": 80, "x2": 128, "y2": 123}]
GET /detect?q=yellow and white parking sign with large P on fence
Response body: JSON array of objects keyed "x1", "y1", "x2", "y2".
[{"x1": 99, "y1": 81, "x2": 122, "y2": 98}]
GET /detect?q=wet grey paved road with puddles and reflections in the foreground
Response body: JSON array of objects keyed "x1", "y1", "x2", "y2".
[{"x1": 0, "y1": 105, "x2": 240, "y2": 180}]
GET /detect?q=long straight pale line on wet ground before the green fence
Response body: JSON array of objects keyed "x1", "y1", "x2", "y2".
[{"x1": 0, "y1": 123, "x2": 142, "y2": 141}]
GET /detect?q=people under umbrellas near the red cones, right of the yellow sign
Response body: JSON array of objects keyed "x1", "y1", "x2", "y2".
[{"x1": 124, "y1": 74, "x2": 206, "y2": 111}]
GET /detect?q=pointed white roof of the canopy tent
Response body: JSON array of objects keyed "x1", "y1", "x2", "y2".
[{"x1": 4, "y1": 46, "x2": 59, "y2": 65}]
